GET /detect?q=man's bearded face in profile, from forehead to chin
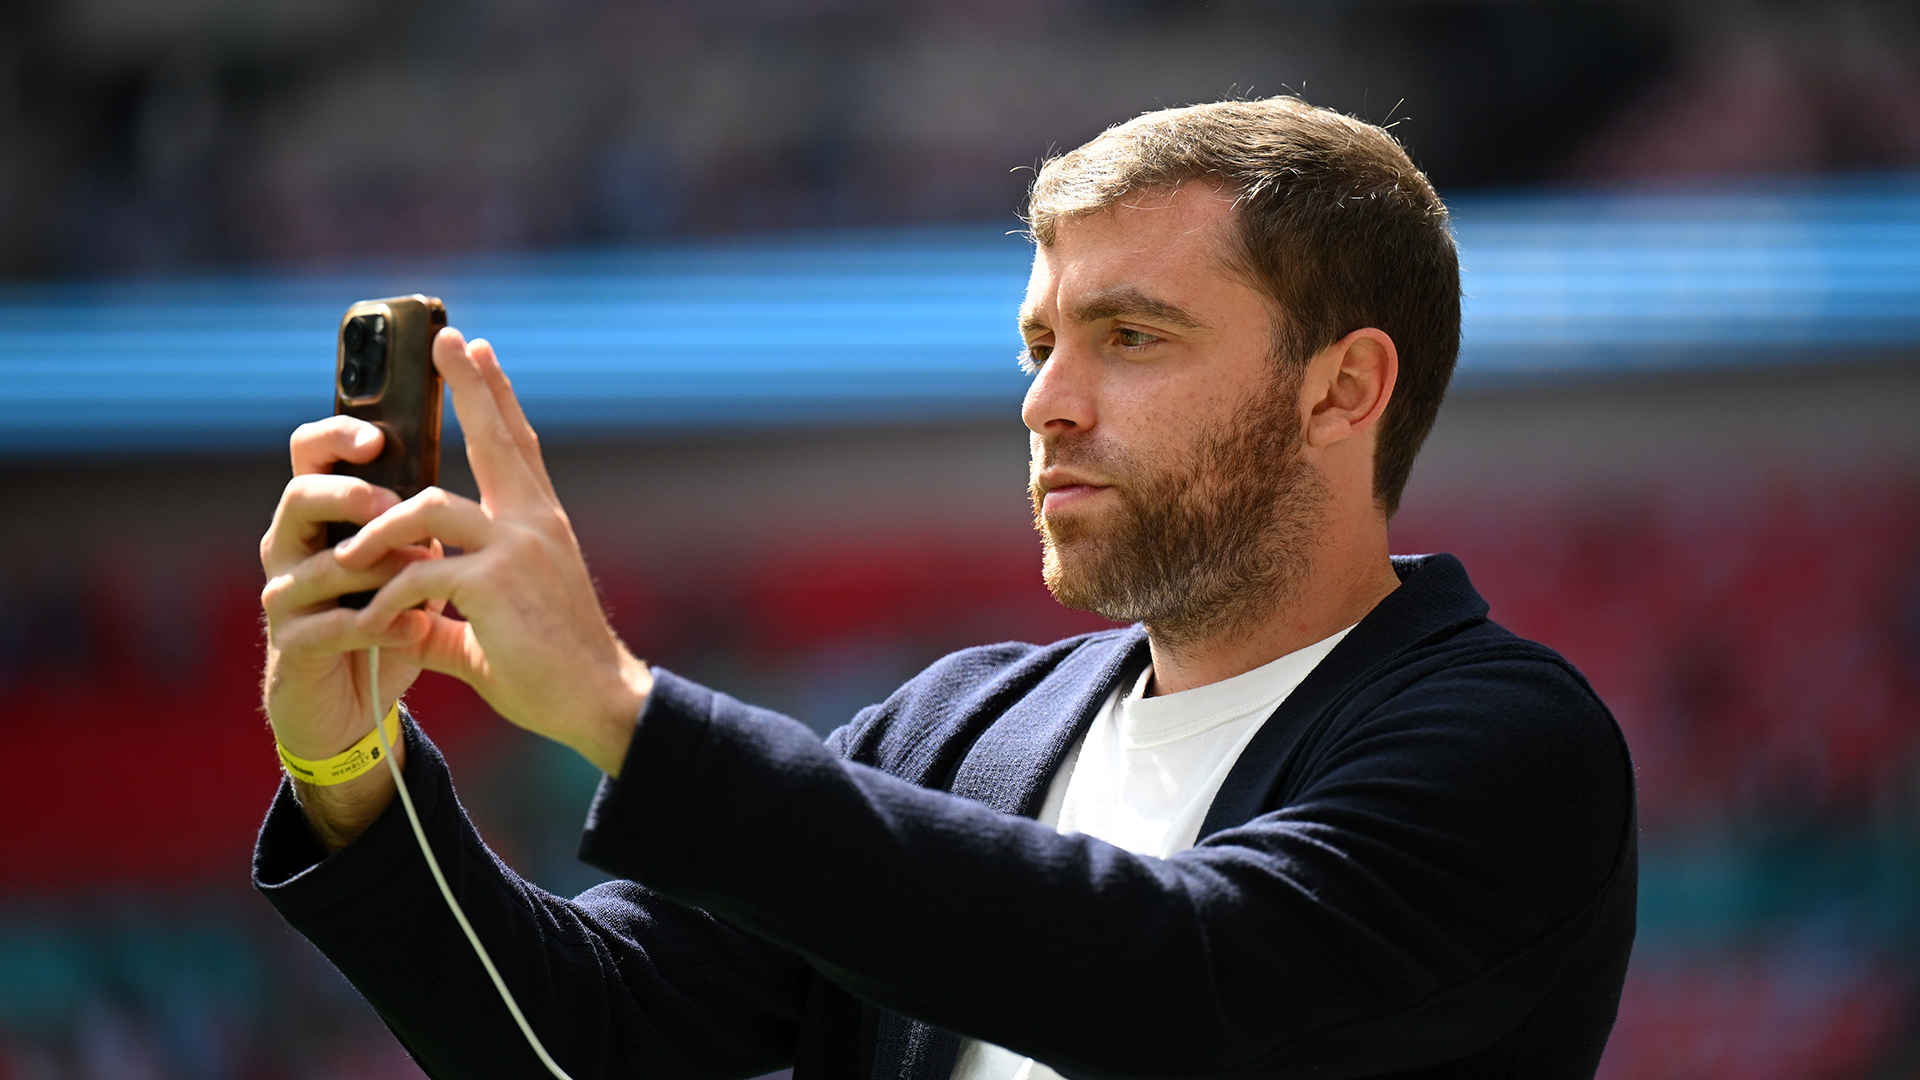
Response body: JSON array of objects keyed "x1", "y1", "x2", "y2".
[{"x1": 1021, "y1": 184, "x2": 1325, "y2": 644}]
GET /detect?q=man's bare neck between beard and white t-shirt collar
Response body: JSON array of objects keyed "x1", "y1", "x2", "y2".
[{"x1": 1146, "y1": 530, "x2": 1400, "y2": 696}]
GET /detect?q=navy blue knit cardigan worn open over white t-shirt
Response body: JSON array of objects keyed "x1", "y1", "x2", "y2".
[{"x1": 253, "y1": 555, "x2": 1636, "y2": 1080}]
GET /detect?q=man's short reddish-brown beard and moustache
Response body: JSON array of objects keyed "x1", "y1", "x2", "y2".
[{"x1": 1031, "y1": 365, "x2": 1327, "y2": 648}]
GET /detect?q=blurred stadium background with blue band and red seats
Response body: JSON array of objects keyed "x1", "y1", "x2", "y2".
[{"x1": 0, "y1": 0, "x2": 1920, "y2": 1080}]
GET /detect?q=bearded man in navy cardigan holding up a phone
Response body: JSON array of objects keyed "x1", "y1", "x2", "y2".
[{"x1": 255, "y1": 98, "x2": 1636, "y2": 1080}]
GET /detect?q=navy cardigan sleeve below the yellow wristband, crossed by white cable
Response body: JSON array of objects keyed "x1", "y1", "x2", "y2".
[{"x1": 253, "y1": 719, "x2": 810, "y2": 1080}]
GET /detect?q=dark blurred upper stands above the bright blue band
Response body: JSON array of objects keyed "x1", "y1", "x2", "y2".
[{"x1": 0, "y1": 0, "x2": 1920, "y2": 277}]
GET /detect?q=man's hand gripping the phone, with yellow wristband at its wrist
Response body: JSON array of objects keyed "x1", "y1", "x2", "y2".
[{"x1": 259, "y1": 417, "x2": 444, "y2": 851}]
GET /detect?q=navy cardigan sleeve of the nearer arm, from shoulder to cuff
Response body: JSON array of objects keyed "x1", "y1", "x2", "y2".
[{"x1": 582, "y1": 659, "x2": 1634, "y2": 1078}]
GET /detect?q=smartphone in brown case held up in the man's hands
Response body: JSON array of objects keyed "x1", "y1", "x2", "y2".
[{"x1": 326, "y1": 294, "x2": 447, "y2": 607}]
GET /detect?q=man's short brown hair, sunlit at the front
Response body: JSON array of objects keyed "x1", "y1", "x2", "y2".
[{"x1": 1027, "y1": 98, "x2": 1459, "y2": 517}]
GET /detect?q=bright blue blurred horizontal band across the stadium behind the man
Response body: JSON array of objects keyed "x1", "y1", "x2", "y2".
[{"x1": 0, "y1": 177, "x2": 1920, "y2": 455}]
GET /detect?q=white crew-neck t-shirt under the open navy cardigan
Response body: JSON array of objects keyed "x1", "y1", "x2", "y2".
[{"x1": 954, "y1": 626, "x2": 1352, "y2": 1080}]
